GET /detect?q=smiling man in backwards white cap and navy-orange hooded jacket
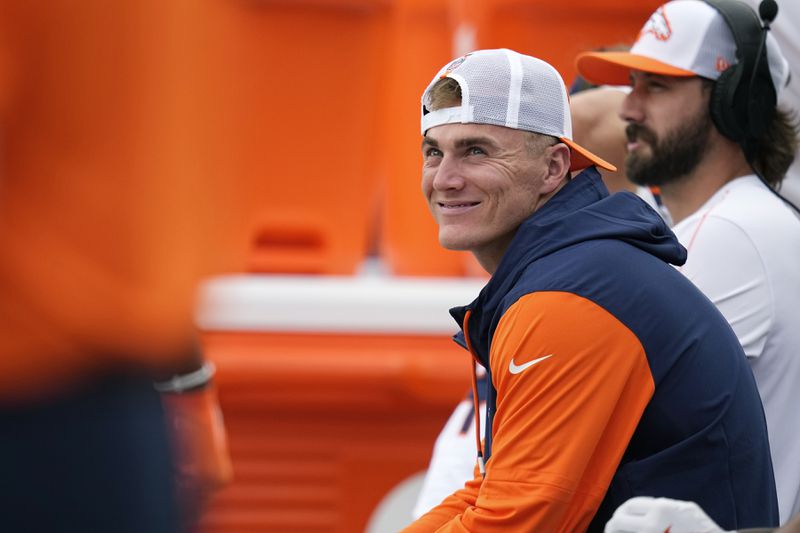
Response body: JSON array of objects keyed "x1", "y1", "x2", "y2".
[{"x1": 408, "y1": 50, "x2": 777, "y2": 533}]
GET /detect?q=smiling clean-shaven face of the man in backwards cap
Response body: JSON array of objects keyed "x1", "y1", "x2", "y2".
[{"x1": 422, "y1": 124, "x2": 553, "y2": 257}]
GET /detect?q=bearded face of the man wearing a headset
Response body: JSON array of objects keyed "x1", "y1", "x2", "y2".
[{"x1": 620, "y1": 72, "x2": 712, "y2": 186}]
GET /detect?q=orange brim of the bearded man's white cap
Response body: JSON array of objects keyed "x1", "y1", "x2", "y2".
[{"x1": 575, "y1": 52, "x2": 697, "y2": 85}]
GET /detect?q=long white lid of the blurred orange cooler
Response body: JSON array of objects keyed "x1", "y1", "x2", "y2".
[{"x1": 196, "y1": 275, "x2": 486, "y2": 335}]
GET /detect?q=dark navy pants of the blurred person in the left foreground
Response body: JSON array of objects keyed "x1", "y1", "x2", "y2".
[{"x1": 0, "y1": 377, "x2": 179, "y2": 533}]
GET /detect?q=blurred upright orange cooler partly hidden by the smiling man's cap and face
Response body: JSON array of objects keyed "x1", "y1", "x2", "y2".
[{"x1": 380, "y1": 0, "x2": 471, "y2": 276}]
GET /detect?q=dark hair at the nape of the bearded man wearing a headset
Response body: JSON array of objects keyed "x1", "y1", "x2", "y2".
[{"x1": 751, "y1": 108, "x2": 799, "y2": 189}]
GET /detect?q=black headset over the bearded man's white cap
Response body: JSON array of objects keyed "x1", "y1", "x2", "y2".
[{"x1": 705, "y1": 0, "x2": 778, "y2": 150}]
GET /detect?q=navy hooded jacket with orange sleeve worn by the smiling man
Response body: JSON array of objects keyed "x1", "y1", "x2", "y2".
[{"x1": 407, "y1": 168, "x2": 778, "y2": 533}]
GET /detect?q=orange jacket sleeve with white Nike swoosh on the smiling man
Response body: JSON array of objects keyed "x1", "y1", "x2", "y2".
[{"x1": 410, "y1": 292, "x2": 654, "y2": 533}]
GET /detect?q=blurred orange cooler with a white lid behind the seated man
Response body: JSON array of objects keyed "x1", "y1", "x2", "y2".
[{"x1": 198, "y1": 275, "x2": 482, "y2": 533}]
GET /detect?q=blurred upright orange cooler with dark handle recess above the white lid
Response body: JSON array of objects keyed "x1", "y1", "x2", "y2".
[{"x1": 194, "y1": 0, "x2": 391, "y2": 275}]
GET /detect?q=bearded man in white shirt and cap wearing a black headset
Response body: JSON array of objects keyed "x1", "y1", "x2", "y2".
[{"x1": 577, "y1": 0, "x2": 800, "y2": 522}]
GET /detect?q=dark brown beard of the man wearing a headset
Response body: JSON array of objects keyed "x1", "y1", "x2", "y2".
[{"x1": 625, "y1": 111, "x2": 711, "y2": 186}]
